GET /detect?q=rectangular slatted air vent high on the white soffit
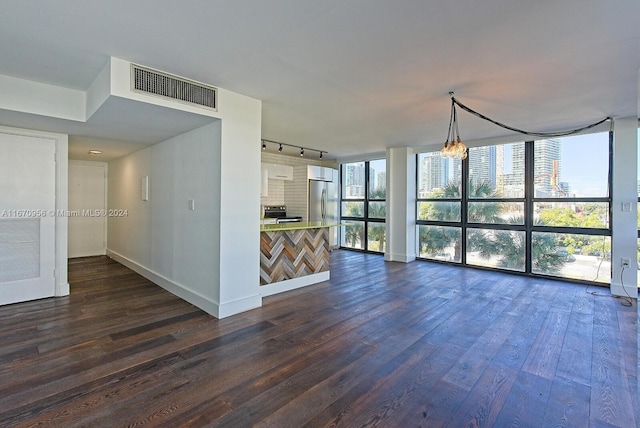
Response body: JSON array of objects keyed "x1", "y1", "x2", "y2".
[{"x1": 131, "y1": 64, "x2": 218, "y2": 110}]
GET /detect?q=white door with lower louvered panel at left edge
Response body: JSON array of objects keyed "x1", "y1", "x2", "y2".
[{"x1": 0, "y1": 133, "x2": 56, "y2": 305}]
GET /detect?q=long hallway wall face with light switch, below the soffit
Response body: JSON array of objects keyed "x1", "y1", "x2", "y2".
[{"x1": 107, "y1": 121, "x2": 220, "y2": 315}]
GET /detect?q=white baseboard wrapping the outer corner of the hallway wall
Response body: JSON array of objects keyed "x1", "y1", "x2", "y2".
[{"x1": 107, "y1": 249, "x2": 262, "y2": 318}]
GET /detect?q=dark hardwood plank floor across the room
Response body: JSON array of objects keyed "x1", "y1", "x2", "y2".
[{"x1": 0, "y1": 251, "x2": 638, "y2": 428}]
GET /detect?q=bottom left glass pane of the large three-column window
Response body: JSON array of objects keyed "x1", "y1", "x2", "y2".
[{"x1": 418, "y1": 225, "x2": 462, "y2": 263}]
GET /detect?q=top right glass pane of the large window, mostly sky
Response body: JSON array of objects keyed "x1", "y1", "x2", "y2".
[{"x1": 533, "y1": 132, "x2": 609, "y2": 198}]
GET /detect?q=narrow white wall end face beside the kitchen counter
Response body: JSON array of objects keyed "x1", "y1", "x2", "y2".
[{"x1": 217, "y1": 90, "x2": 262, "y2": 318}]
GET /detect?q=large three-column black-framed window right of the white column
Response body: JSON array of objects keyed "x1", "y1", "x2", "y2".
[{"x1": 416, "y1": 133, "x2": 612, "y2": 283}]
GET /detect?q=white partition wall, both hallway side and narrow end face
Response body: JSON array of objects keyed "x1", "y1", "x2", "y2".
[{"x1": 107, "y1": 90, "x2": 262, "y2": 318}]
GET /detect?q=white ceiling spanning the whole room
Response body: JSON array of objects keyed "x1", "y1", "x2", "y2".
[{"x1": 0, "y1": 0, "x2": 640, "y2": 157}]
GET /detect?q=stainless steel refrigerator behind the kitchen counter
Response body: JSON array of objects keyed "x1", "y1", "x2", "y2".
[{"x1": 308, "y1": 180, "x2": 339, "y2": 249}]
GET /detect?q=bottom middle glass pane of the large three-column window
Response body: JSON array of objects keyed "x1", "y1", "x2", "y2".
[{"x1": 467, "y1": 229, "x2": 526, "y2": 272}]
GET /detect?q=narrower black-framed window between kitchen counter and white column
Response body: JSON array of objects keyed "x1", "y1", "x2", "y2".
[{"x1": 340, "y1": 159, "x2": 387, "y2": 253}]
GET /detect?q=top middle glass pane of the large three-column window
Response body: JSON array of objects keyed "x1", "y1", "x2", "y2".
[{"x1": 468, "y1": 142, "x2": 524, "y2": 199}]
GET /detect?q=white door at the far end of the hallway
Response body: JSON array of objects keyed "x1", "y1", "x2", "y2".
[{"x1": 68, "y1": 161, "x2": 107, "y2": 258}]
